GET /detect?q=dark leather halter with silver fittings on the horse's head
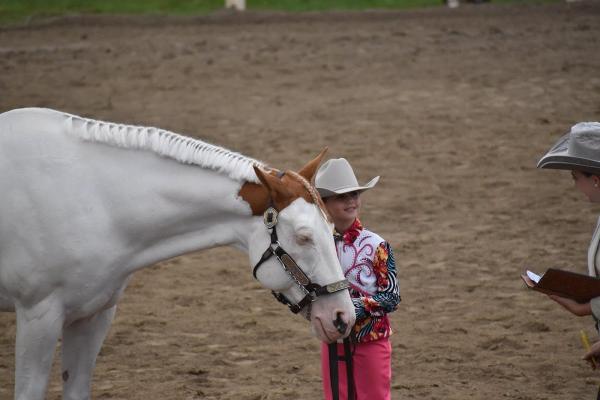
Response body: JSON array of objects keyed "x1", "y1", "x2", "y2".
[{"x1": 252, "y1": 173, "x2": 350, "y2": 314}]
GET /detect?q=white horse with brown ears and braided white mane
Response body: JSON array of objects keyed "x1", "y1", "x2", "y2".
[{"x1": 0, "y1": 108, "x2": 354, "y2": 400}]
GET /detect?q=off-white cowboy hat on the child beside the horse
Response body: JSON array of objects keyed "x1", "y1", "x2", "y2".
[{"x1": 315, "y1": 158, "x2": 379, "y2": 197}]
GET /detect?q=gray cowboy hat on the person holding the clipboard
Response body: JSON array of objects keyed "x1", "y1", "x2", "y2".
[{"x1": 537, "y1": 122, "x2": 600, "y2": 175}]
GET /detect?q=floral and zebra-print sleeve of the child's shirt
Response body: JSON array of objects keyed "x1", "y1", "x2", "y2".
[{"x1": 352, "y1": 242, "x2": 400, "y2": 319}]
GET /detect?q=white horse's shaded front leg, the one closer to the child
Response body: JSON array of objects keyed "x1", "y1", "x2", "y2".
[{"x1": 62, "y1": 306, "x2": 117, "y2": 400}]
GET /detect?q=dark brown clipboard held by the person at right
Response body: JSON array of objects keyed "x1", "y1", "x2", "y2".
[{"x1": 521, "y1": 268, "x2": 600, "y2": 303}]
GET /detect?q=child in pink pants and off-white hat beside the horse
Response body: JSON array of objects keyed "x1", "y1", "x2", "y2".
[{"x1": 315, "y1": 158, "x2": 400, "y2": 400}]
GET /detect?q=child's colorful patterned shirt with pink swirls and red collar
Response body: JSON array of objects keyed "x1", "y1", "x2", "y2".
[{"x1": 335, "y1": 219, "x2": 400, "y2": 342}]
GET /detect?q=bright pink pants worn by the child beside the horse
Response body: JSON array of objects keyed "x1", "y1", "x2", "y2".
[{"x1": 321, "y1": 338, "x2": 392, "y2": 400}]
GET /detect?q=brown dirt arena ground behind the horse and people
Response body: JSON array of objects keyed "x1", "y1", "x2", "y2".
[{"x1": 0, "y1": 1, "x2": 600, "y2": 400}]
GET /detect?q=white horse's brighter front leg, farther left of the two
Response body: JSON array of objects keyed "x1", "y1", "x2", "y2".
[{"x1": 15, "y1": 298, "x2": 64, "y2": 400}]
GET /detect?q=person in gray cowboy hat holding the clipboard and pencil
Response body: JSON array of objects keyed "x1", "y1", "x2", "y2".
[{"x1": 538, "y1": 122, "x2": 600, "y2": 368}]
